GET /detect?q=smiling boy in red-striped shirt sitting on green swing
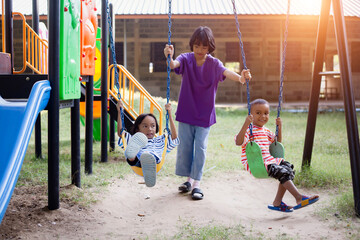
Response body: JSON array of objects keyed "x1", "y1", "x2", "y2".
[{"x1": 235, "y1": 99, "x2": 319, "y2": 212}]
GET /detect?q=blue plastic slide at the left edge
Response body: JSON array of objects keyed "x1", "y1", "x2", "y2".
[{"x1": 0, "y1": 80, "x2": 51, "y2": 223}]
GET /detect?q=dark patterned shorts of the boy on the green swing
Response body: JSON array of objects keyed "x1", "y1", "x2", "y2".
[{"x1": 268, "y1": 161, "x2": 295, "y2": 184}]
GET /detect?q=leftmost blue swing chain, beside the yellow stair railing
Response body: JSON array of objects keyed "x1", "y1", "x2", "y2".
[{"x1": 106, "y1": 0, "x2": 126, "y2": 134}]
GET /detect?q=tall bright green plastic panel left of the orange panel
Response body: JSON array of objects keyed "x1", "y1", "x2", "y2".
[{"x1": 59, "y1": 0, "x2": 81, "y2": 100}]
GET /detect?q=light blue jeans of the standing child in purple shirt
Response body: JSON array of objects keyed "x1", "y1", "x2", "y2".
[{"x1": 175, "y1": 122, "x2": 210, "y2": 181}]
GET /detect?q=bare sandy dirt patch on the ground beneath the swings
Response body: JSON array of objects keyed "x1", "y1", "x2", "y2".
[{"x1": 0, "y1": 172, "x2": 360, "y2": 239}]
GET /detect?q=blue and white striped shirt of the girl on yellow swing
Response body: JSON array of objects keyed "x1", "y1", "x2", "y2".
[{"x1": 118, "y1": 131, "x2": 180, "y2": 164}]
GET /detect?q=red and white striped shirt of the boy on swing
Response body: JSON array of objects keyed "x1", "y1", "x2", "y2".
[{"x1": 235, "y1": 125, "x2": 284, "y2": 172}]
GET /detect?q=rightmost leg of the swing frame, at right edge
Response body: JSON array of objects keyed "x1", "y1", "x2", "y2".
[{"x1": 332, "y1": 0, "x2": 360, "y2": 217}]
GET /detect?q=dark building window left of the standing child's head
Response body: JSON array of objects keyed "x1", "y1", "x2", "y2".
[{"x1": 149, "y1": 42, "x2": 172, "y2": 72}]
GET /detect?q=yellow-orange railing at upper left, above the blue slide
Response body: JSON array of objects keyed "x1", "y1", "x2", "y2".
[{"x1": 13, "y1": 12, "x2": 48, "y2": 74}]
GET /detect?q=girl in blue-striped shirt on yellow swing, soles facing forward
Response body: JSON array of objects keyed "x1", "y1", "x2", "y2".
[{"x1": 116, "y1": 100, "x2": 179, "y2": 187}]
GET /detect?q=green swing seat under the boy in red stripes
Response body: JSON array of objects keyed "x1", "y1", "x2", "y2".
[{"x1": 245, "y1": 141, "x2": 284, "y2": 178}]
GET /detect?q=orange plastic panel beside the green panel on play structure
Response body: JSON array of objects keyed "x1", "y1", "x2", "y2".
[{"x1": 80, "y1": 0, "x2": 97, "y2": 75}]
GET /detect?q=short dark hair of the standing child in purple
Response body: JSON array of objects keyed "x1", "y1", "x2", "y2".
[{"x1": 189, "y1": 26, "x2": 215, "y2": 53}]
